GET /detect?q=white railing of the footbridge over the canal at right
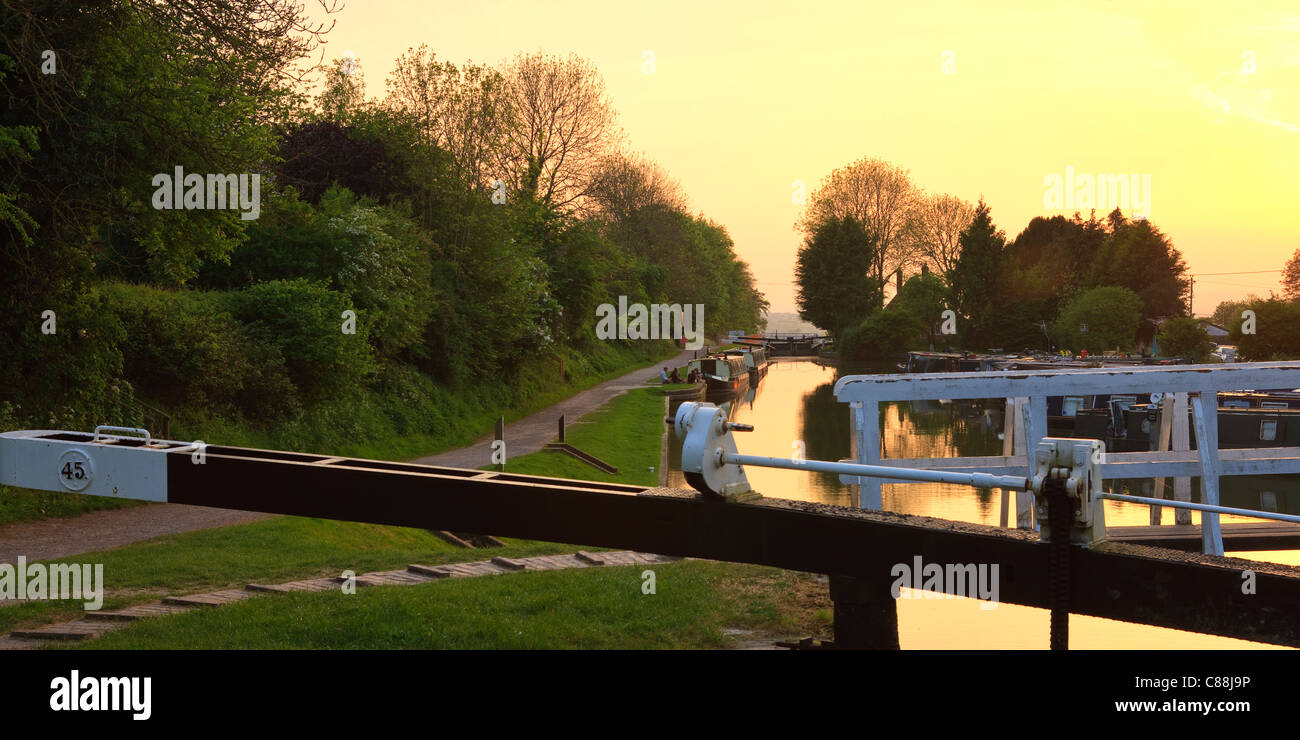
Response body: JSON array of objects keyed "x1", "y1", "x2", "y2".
[{"x1": 835, "y1": 362, "x2": 1300, "y2": 555}]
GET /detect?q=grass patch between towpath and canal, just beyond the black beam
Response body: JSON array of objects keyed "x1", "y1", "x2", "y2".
[{"x1": 482, "y1": 388, "x2": 666, "y2": 485}]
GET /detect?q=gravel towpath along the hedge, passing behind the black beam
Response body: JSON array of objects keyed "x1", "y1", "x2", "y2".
[{"x1": 0, "y1": 351, "x2": 693, "y2": 564}]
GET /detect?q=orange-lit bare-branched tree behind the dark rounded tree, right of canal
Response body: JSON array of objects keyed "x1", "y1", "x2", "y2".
[{"x1": 800, "y1": 157, "x2": 918, "y2": 306}]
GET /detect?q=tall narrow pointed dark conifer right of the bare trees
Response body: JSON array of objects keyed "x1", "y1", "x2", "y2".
[{"x1": 949, "y1": 199, "x2": 1006, "y2": 347}]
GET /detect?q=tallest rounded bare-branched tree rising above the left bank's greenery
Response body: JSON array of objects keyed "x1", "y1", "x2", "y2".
[{"x1": 504, "y1": 52, "x2": 615, "y2": 207}]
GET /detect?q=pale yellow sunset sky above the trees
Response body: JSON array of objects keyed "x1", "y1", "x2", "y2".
[{"x1": 309, "y1": 0, "x2": 1300, "y2": 315}]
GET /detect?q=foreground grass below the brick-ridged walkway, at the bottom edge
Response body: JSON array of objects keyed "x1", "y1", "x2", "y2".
[{"x1": 65, "y1": 561, "x2": 826, "y2": 650}]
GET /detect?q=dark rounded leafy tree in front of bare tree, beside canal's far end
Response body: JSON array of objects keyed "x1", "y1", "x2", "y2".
[{"x1": 794, "y1": 216, "x2": 880, "y2": 334}]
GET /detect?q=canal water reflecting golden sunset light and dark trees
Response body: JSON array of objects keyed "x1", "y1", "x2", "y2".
[{"x1": 668, "y1": 358, "x2": 1300, "y2": 650}]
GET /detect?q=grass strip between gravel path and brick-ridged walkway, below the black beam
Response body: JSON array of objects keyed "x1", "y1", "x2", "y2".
[{"x1": 0, "y1": 516, "x2": 590, "y2": 631}]
